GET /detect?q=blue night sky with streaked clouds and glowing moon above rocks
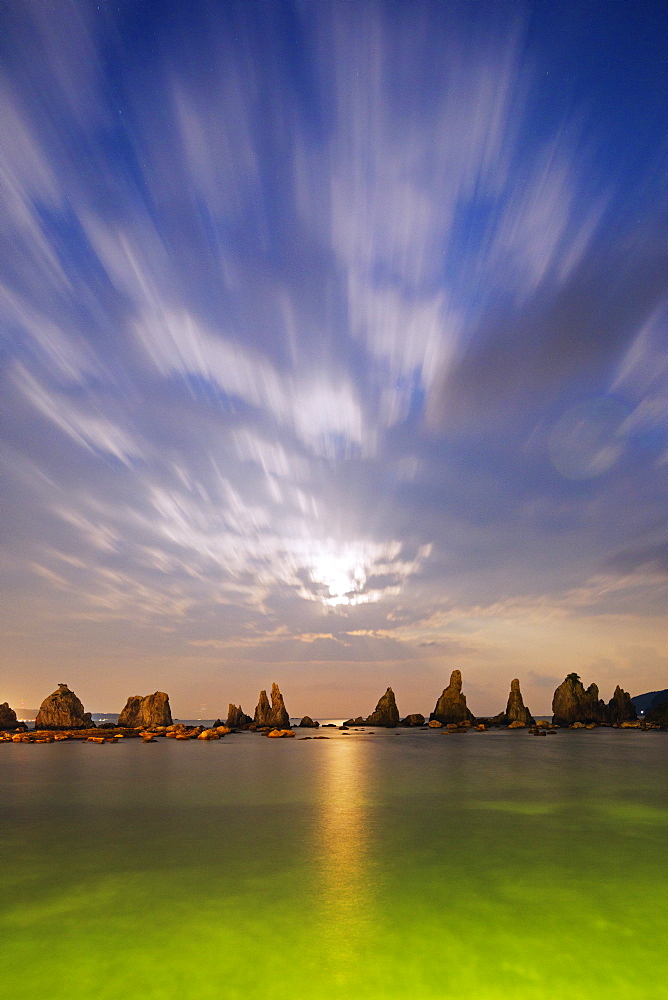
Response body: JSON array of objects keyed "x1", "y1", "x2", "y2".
[{"x1": 0, "y1": 0, "x2": 668, "y2": 718}]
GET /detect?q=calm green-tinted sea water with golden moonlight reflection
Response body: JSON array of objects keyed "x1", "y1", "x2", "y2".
[{"x1": 0, "y1": 729, "x2": 668, "y2": 1000}]
